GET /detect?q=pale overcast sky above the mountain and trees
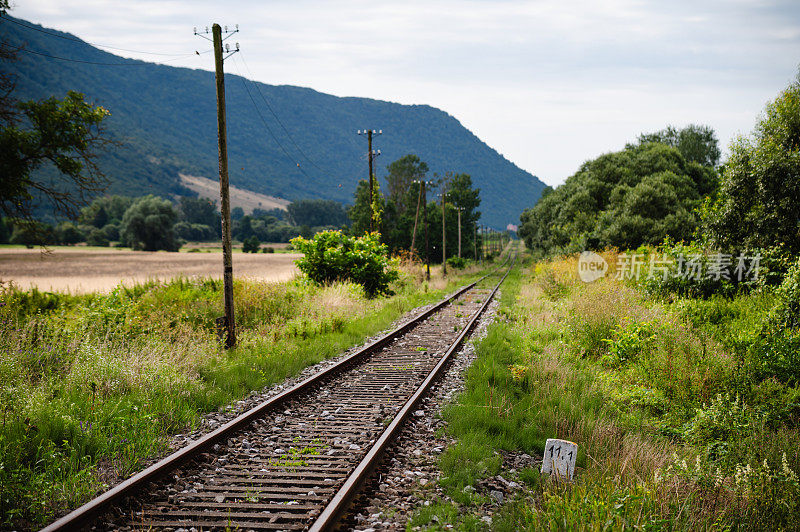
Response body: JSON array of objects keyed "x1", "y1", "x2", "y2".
[{"x1": 11, "y1": 0, "x2": 800, "y2": 185}]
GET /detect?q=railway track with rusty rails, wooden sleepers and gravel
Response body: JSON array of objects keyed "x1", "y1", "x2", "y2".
[{"x1": 43, "y1": 251, "x2": 513, "y2": 532}]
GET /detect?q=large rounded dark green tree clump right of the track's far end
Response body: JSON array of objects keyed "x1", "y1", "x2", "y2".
[{"x1": 519, "y1": 142, "x2": 716, "y2": 254}]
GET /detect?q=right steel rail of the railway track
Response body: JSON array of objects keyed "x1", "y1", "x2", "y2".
[{"x1": 309, "y1": 250, "x2": 517, "y2": 532}]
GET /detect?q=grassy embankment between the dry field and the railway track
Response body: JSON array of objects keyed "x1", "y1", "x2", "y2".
[{"x1": 0, "y1": 258, "x2": 488, "y2": 529}]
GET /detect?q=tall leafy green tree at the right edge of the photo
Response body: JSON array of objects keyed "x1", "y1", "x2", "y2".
[{"x1": 704, "y1": 74, "x2": 800, "y2": 255}]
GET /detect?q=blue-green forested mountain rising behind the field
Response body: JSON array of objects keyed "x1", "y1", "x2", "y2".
[{"x1": 0, "y1": 17, "x2": 544, "y2": 228}]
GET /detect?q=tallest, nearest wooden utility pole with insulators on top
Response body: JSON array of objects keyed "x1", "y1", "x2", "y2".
[{"x1": 194, "y1": 24, "x2": 239, "y2": 349}]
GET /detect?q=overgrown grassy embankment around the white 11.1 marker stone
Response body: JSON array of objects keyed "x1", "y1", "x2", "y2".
[{"x1": 416, "y1": 247, "x2": 800, "y2": 531}]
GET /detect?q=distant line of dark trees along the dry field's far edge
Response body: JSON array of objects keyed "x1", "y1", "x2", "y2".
[{"x1": 0, "y1": 195, "x2": 348, "y2": 251}]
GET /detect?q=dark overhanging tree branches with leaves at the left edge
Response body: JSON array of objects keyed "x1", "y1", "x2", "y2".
[{"x1": 0, "y1": 91, "x2": 110, "y2": 219}]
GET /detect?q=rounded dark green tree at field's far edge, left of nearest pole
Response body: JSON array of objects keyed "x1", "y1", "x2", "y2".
[{"x1": 120, "y1": 195, "x2": 180, "y2": 251}]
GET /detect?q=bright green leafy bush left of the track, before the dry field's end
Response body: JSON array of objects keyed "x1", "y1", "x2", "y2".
[{"x1": 292, "y1": 231, "x2": 399, "y2": 297}]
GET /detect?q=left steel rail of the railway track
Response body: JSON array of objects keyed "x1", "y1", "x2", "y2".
[{"x1": 40, "y1": 257, "x2": 509, "y2": 532}]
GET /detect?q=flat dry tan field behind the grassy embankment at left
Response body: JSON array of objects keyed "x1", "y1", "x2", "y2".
[{"x1": 0, "y1": 248, "x2": 300, "y2": 293}]
